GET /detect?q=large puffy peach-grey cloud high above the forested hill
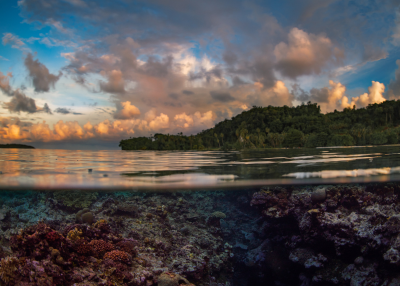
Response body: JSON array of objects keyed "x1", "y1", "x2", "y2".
[{"x1": 274, "y1": 28, "x2": 343, "y2": 79}]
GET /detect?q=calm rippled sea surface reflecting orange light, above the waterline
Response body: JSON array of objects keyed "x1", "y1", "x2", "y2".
[{"x1": 0, "y1": 146, "x2": 400, "y2": 189}]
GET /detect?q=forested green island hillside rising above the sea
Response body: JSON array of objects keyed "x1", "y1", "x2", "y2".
[{"x1": 119, "y1": 100, "x2": 400, "y2": 150}]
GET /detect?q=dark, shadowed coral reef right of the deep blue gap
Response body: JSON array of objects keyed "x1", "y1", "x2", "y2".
[{"x1": 248, "y1": 183, "x2": 400, "y2": 285}]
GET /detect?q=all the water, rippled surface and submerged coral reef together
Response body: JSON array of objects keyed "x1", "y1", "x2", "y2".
[{"x1": 0, "y1": 146, "x2": 400, "y2": 286}]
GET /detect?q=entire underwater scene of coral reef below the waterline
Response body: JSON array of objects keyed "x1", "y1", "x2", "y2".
[{"x1": 0, "y1": 182, "x2": 400, "y2": 286}]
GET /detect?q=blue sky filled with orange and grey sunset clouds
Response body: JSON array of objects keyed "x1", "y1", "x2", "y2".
[{"x1": 0, "y1": 0, "x2": 400, "y2": 149}]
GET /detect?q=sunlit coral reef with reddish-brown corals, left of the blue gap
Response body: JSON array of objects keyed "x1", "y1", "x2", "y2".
[{"x1": 0, "y1": 189, "x2": 239, "y2": 286}]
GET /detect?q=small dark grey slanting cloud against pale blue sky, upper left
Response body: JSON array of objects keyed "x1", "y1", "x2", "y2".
[{"x1": 24, "y1": 53, "x2": 62, "y2": 92}]
